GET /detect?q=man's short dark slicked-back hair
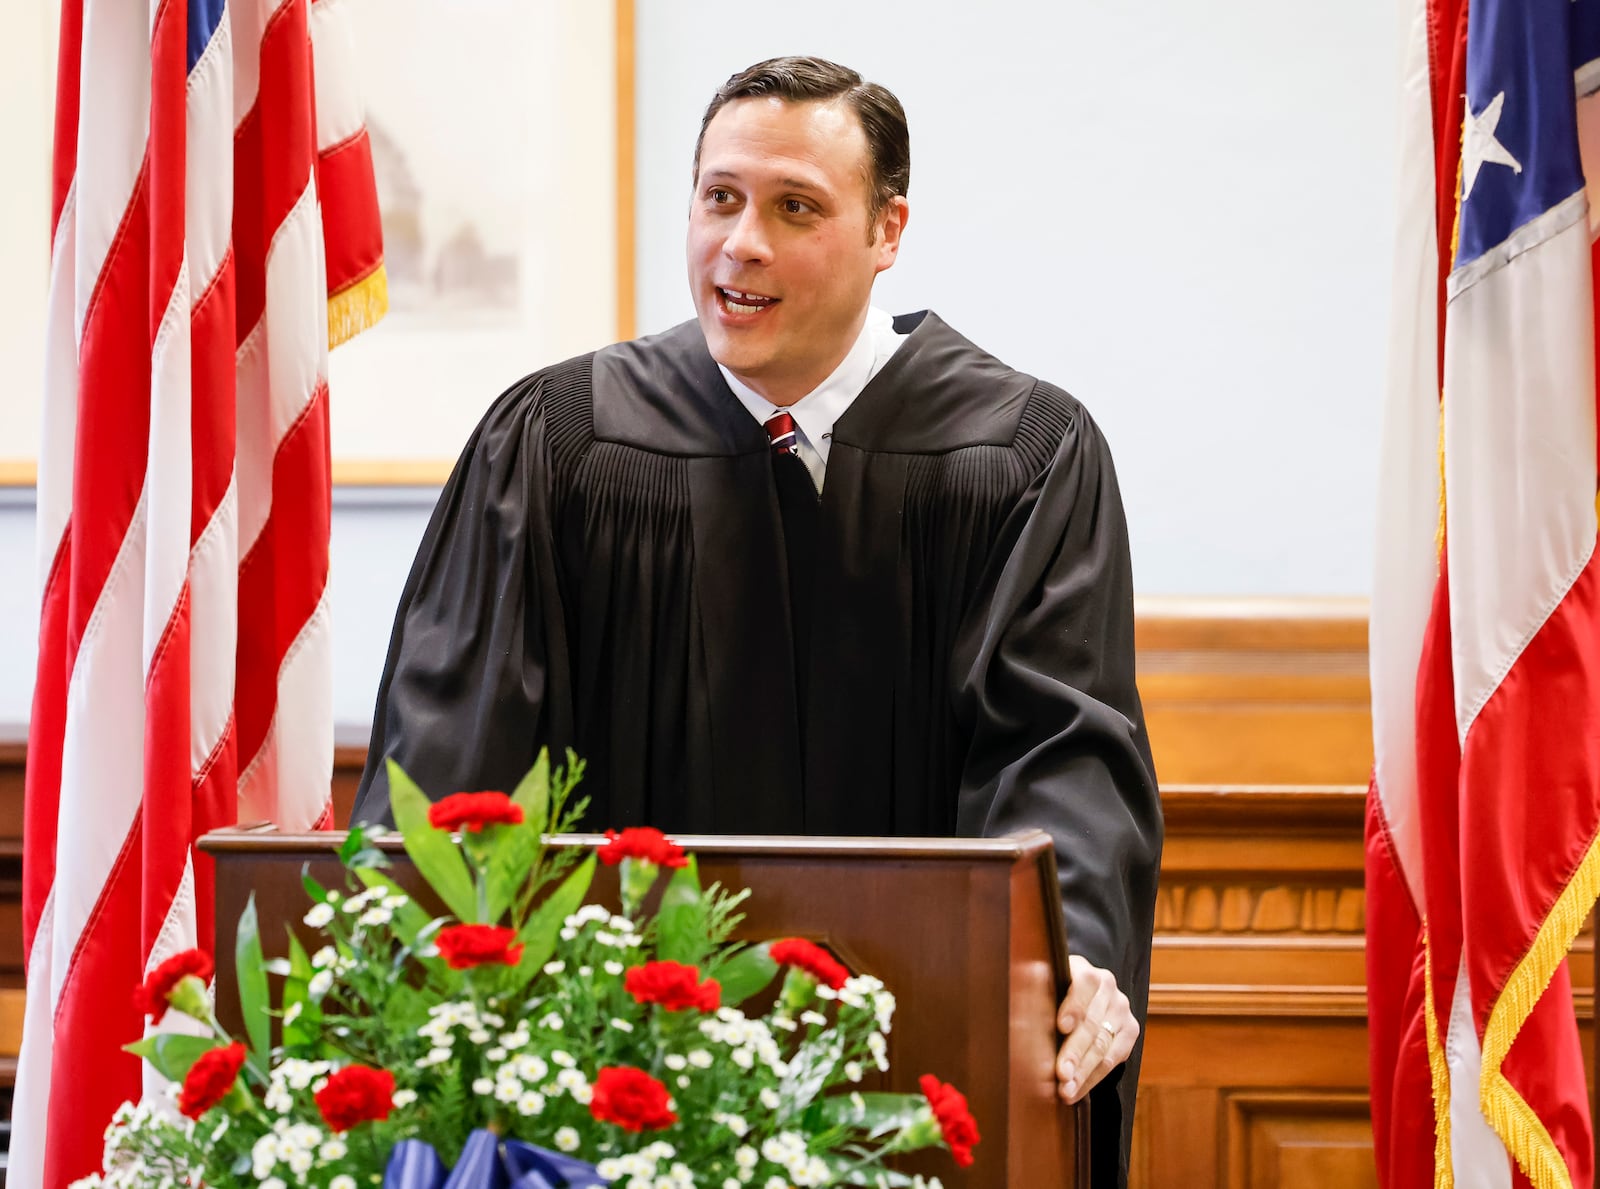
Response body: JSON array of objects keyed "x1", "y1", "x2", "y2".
[{"x1": 694, "y1": 58, "x2": 910, "y2": 222}]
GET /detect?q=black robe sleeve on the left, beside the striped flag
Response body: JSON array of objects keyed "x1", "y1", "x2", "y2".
[{"x1": 354, "y1": 374, "x2": 570, "y2": 823}]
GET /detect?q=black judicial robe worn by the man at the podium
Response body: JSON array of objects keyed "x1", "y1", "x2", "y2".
[{"x1": 355, "y1": 312, "x2": 1162, "y2": 1184}]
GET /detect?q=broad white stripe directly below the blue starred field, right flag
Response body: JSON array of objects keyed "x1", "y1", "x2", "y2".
[{"x1": 1445, "y1": 192, "x2": 1595, "y2": 739}]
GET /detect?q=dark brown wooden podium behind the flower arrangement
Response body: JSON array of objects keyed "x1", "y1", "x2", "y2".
[{"x1": 200, "y1": 829, "x2": 1090, "y2": 1189}]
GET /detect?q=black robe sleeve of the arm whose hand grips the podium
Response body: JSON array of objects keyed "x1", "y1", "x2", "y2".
[{"x1": 954, "y1": 394, "x2": 1162, "y2": 1186}]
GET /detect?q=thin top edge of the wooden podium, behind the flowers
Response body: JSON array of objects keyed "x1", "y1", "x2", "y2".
[{"x1": 198, "y1": 823, "x2": 1051, "y2": 863}]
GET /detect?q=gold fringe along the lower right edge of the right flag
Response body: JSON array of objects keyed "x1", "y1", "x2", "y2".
[{"x1": 1478, "y1": 837, "x2": 1600, "y2": 1189}]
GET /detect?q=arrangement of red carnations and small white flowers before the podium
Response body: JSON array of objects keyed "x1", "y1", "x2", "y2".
[{"x1": 77, "y1": 755, "x2": 978, "y2": 1189}]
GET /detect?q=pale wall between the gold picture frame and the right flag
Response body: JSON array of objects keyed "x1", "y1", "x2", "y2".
[{"x1": 638, "y1": 0, "x2": 1398, "y2": 595}]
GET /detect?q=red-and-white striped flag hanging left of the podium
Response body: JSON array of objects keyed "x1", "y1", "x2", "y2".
[{"x1": 8, "y1": 0, "x2": 386, "y2": 1189}]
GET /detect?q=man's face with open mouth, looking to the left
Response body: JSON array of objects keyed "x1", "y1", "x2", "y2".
[{"x1": 688, "y1": 98, "x2": 906, "y2": 405}]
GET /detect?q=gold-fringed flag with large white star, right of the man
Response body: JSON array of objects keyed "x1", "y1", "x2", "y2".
[{"x1": 1366, "y1": 0, "x2": 1600, "y2": 1189}]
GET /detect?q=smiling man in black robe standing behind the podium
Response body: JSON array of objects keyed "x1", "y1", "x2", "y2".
[{"x1": 357, "y1": 58, "x2": 1162, "y2": 1184}]
